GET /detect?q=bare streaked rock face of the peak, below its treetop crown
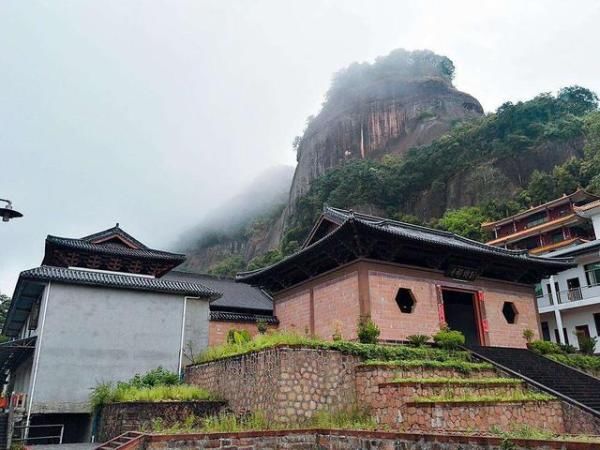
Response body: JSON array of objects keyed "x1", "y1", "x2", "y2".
[{"x1": 286, "y1": 77, "x2": 483, "y2": 216}]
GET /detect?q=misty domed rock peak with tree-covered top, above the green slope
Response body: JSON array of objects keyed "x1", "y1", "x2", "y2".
[{"x1": 286, "y1": 50, "x2": 483, "y2": 218}]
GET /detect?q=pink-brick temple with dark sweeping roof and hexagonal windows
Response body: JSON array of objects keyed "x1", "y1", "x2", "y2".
[{"x1": 236, "y1": 207, "x2": 573, "y2": 347}]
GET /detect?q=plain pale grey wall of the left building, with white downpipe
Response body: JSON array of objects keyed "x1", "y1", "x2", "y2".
[{"x1": 32, "y1": 283, "x2": 209, "y2": 412}]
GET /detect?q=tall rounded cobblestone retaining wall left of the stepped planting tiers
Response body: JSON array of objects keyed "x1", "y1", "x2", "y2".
[{"x1": 185, "y1": 346, "x2": 360, "y2": 423}]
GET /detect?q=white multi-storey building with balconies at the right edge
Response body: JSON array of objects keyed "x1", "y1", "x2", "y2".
[{"x1": 537, "y1": 200, "x2": 600, "y2": 352}]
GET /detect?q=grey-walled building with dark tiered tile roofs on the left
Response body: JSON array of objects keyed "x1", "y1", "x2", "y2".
[{"x1": 0, "y1": 224, "x2": 277, "y2": 442}]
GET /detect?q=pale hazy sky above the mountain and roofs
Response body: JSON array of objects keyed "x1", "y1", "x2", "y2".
[{"x1": 0, "y1": 0, "x2": 600, "y2": 295}]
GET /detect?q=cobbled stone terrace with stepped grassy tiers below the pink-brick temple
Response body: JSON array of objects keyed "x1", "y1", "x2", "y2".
[{"x1": 185, "y1": 346, "x2": 600, "y2": 434}]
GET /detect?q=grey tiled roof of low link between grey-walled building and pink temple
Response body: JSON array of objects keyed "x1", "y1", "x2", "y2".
[{"x1": 162, "y1": 270, "x2": 273, "y2": 312}]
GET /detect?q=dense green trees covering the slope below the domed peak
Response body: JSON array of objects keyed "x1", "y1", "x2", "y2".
[{"x1": 283, "y1": 86, "x2": 600, "y2": 245}]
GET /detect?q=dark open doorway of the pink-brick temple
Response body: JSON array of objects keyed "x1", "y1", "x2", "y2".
[{"x1": 442, "y1": 289, "x2": 481, "y2": 345}]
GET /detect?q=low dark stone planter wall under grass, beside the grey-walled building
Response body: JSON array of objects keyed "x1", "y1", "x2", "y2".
[{"x1": 98, "y1": 400, "x2": 227, "y2": 442}]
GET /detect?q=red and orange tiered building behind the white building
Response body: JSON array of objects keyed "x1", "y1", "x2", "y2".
[{"x1": 481, "y1": 189, "x2": 600, "y2": 255}]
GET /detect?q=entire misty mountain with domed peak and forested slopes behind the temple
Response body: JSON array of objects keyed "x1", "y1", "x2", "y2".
[{"x1": 180, "y1": 50, "x2": 600, "y2": 275}]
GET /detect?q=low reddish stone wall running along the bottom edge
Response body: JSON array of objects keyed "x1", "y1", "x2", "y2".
[{"x1": 144, "y1": 430, "x2": 595, "y2": 450}]
